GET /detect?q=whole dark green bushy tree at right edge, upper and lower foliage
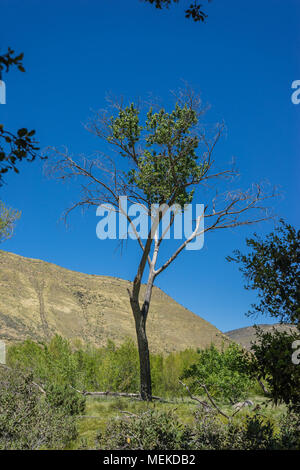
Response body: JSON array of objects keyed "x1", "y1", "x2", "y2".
[{"x1": 227, "y1": 219, "x2": 300, "y2": 413}]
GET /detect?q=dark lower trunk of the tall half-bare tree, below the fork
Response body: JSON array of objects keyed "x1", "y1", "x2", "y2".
[{"x1": 133, "y1": 309, "x2": 152, "y2": 401}]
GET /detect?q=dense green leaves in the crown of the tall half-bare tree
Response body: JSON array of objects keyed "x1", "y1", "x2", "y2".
[{"x1": 107, "y1": 103, "x2": 209, "y2": 207}]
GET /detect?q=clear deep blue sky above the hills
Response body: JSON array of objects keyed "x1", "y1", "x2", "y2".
[{"x1": 0, "y1": 0, "x2": 300, "y2": 331}]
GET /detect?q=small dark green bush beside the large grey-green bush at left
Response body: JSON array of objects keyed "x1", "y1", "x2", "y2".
[{"x1": 45, "y1": 384, "x2": 86, "y2": 416}]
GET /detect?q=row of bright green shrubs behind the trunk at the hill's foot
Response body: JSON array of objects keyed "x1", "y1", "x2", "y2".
[{"x1": 8, "y1": 336, "x2": 202, "y2": 396}]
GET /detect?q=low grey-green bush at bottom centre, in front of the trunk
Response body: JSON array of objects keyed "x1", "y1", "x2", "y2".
[{"x1": 97, "y1": 410, "x2": 191, "y2": 450}]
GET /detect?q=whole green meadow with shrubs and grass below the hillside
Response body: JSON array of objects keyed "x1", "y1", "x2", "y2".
[{"x1": 0, "y1": 336, "x2": 299, "y2": 450}]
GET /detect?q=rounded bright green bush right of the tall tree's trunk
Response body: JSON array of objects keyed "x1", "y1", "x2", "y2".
[{"x1": 182, "y1": 344, "x2": 254, "y2": 403}]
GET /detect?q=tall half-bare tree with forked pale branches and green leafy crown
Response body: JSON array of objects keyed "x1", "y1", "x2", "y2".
[{"x1": 52, "y1": 90, "x2": 274, "y2": 400}]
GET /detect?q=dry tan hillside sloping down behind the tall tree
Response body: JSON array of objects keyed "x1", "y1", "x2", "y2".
[{"x1": 0, "y1": 250, "x2": 228, "y2": 352}]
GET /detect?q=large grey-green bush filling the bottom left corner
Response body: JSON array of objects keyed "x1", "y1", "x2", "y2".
[{"x1": 0, "y1": 369, "x2": 77, "y2": 450}]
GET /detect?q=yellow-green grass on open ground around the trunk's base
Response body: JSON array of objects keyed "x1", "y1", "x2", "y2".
[{"x1": 71, "y1": 396, "x2": 285, "y2": 449}]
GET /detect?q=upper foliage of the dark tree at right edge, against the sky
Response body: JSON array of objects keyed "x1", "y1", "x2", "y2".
[{"x1": 227, "y1": 220, "x2": 300, "y2": 328}]
